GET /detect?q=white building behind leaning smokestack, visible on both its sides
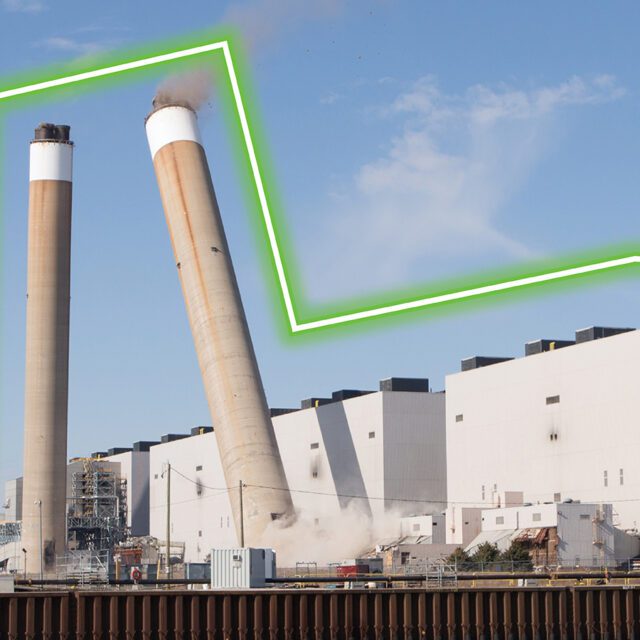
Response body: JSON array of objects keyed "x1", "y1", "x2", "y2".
[{"x1": 149, "y1": 379, "x2": 446, "y2": 562}]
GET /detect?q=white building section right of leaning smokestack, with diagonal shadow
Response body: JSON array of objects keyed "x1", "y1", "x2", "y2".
[{"x1": 273, "y1": 378, "x2": 446, "y2": 525}]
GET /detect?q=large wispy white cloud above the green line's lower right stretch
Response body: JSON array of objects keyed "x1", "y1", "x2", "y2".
[{"x1": 305, "y1": 76, "x2": 624, "y2": 297}]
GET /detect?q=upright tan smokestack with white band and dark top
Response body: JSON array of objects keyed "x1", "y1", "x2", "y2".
[{"x1": 22, "y1": 124, "x2": 73, "y2": 574}]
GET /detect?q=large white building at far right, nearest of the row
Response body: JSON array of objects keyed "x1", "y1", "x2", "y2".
[{"x1": 446, "y1": 327, "x2": 640, "y2": 530}]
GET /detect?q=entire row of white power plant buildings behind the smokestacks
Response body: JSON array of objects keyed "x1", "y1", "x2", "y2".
[{"x1": 2, "y1": 327, "x2": 640, "y2": 567}]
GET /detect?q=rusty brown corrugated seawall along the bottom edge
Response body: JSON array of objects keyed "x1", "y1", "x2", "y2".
[{"x1": 0, "y1": 587, "x2": 640, "y2": 640}]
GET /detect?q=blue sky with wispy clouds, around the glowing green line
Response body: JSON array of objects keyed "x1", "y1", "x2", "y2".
[{"x1": 0, "y1": 0, "x2": 640, "y2": 496}]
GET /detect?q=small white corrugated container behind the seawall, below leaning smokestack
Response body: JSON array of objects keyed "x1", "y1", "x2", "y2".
[{"x1": 211, "y1": 547, "x2": 276, "y2": 589}]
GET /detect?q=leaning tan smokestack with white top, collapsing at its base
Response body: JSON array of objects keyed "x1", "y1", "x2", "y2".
[{"x1": 146, "y1": 105, "x2": 293, "y2": 546}]
